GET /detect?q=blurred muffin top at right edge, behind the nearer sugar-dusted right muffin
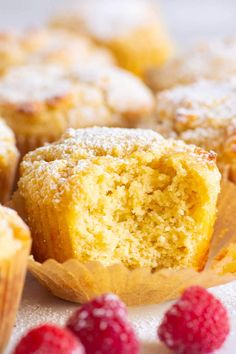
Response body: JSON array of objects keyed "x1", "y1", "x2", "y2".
[{"x1": 146, "y1": 37, "x2": 236, "y2": 91}]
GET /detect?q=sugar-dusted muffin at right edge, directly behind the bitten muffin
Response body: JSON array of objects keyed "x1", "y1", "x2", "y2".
[{"x1": 141, "y1": 77, "x2": 236, "y2": 182}]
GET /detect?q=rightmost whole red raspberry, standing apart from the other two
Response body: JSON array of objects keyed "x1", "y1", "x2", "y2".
[{"x1": 158, "y1": 286, "x2": 230, "y2": 354}]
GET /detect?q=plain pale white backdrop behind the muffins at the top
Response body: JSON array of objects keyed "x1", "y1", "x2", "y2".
[{"x1": 0, "y1": 0, "x2": 236, "y2": 42}]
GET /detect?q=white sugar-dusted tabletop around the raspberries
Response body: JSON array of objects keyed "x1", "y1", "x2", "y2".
[{"x1": 5, "y1": 276, "x2": 236, "y2": 354}]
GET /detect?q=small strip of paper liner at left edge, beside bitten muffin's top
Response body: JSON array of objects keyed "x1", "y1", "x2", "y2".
[{"x1": 0, "y1": 153, "x2": 19, "y2": 204}]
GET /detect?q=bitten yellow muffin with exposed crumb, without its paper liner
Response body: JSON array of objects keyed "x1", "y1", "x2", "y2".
[{"x1": 18, "y1": 128, "x2": 220, "y2": 269}]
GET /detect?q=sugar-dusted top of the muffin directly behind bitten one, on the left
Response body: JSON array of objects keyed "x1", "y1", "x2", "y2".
[{"x1": 0, "y1": 65, "x2": 153, "y2": 115}]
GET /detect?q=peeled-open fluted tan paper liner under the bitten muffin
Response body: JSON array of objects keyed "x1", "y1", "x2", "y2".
[{"x1": 13, "y1": 181, "x2": 236, "y2": 305}]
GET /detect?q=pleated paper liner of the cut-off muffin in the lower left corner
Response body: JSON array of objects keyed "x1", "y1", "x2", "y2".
[{"x1": 0, "y1": 240, "x2": 30, "y2": 353}]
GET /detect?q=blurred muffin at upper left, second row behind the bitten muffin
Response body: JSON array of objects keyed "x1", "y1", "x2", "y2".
[{"x1": 0, "y1": 28, "x2": 115, "y2": 75}]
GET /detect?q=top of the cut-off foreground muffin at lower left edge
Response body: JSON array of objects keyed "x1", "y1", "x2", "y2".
[{"x1": 0, "y1": 206, "x2": 30, "y2": 259}]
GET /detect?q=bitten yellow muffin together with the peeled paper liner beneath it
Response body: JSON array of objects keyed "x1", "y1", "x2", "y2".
[{"x1": 12, "y1": 128, "x2": 232, "y2": 304}]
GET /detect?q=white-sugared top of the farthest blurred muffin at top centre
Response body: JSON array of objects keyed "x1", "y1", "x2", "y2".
[{"x1": 51, "y1": 0, "x2": 159, "y2": 42}]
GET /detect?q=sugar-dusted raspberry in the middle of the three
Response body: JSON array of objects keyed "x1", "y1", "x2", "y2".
[{"x1": 67, "y1": 294, "x2": 139, "y2": 354}]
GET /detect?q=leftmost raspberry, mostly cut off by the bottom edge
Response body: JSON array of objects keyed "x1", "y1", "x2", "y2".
[{"x1": 14, "y1": 324, "x2": 85, "y2": 354}]
